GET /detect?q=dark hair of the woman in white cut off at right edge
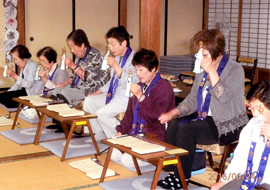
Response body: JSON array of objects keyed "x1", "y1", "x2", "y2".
[{"x1": 246, "y1": 80, "x2": 270, "y2": 110}]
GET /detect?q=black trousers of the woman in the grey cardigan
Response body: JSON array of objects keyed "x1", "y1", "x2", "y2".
[{"x1": 166, "y1": 113, "x2": 218, "y2": 179}]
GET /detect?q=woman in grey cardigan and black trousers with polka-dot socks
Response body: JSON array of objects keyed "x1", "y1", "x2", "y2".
[{"x1": 158, "y1": 29, "x2": 248, "y2": 189}]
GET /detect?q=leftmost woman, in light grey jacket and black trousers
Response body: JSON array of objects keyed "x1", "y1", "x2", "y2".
[{"x1": 0, "y1": 45, "x2": 44, "y2": 108}]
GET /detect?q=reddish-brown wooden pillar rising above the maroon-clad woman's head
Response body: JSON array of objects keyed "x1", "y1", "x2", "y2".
[{"x1": 140, "y1": 0, "x2": 161, "y2": 58}]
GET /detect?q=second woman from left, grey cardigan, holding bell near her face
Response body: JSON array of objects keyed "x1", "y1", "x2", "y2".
[{"x1": 37, "y1": 46, "x2": 69, "y2": 95}]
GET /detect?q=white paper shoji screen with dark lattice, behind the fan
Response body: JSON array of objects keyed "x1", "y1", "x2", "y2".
[{"x1": 208, "y1": 0, "x2": 270, "y2": 69}]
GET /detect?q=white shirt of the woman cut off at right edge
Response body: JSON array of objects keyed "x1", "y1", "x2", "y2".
[{"x1": 221, "y1": 118, "x2": 270, "y2": 184}]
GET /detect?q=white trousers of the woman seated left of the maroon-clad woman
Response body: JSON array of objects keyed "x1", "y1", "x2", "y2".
[{"x1": 83, "y1": 93, "x2": 127, "y2": 140}]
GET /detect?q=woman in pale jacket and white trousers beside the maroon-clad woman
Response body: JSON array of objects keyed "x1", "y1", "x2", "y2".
[{"x1": 83, "y1": 26, "x2": 139, "y2": 140}]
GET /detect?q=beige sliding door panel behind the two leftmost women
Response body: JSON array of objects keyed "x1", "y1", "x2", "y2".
[{"x1": 25, "y1": 0, "x2": 72, "y2": 63}]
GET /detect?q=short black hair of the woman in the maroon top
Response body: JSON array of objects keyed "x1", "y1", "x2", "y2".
[{"x1": 132, "y1": 48, "x2": 159, "y2": 71}]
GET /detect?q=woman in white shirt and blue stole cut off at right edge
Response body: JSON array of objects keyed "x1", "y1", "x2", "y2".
[{"x1": 211, "y1": 80, "x2": 270, "y2": 190}]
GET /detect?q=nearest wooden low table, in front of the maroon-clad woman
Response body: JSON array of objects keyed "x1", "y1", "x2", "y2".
[{"x1": 99, "y1": 134, "x2": 188, "y2": 189}]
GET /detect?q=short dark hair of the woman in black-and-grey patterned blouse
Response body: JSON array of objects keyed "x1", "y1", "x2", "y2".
[{"x1": 67, "y1": 29, "x2": 90, "y2": 47}]
